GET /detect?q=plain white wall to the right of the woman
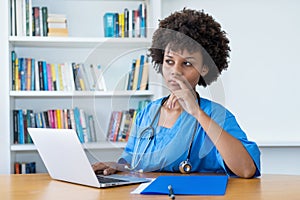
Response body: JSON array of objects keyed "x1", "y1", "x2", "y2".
[{"x1": 162, "y1": 0, "x2": 300, "y2": 174}]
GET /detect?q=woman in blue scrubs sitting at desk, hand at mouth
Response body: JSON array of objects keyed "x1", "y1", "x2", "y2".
[{"x1": 93, "y1": 9, "x2": 260, "y2": 178}]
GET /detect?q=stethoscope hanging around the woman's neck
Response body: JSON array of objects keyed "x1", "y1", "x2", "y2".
[{"x1": 125, "y1": 92, "x2": 200, "y2": 174}]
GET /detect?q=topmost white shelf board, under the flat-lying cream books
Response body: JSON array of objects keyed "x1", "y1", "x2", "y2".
[{"x1": 9, "y1": 36, "x2": 151, "y2": 48}]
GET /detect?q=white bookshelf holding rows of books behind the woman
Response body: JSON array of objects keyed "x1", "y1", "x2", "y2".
[{"x1": 0, "y1": 0, "x2": 160, "y2": 174}]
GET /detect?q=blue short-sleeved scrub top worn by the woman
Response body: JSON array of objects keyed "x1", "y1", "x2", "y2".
[{"x1": 119, "y1": 98, "x2": 260, "y2": 176}]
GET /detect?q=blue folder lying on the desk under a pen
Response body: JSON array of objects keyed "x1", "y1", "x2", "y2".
[{"x1": 141, "y1": 175, "x2": 228, "y2": 195}]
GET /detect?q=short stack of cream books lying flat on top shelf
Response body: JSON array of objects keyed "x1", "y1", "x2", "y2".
[{"x1": 47, "y1": 13, "x2": 69, "y2": 36}]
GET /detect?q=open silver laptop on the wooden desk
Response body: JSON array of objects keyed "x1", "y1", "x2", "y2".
[{"x1": 28, "y1": 128, "x2": 149, "y2": 188}]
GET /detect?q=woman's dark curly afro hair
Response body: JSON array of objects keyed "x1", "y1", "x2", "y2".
[{"x1": 149, "y1": 8, "x2": 230, "y2": 87}]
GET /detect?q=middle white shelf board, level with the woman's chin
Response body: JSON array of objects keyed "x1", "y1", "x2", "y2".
[{"x1": 9, "y1": 90, "x2": 153, "y2": 98}]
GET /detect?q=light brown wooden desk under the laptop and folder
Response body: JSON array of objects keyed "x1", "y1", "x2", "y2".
[{"x1": 0, "y1": 173, "x2": 300, "y2": 200}]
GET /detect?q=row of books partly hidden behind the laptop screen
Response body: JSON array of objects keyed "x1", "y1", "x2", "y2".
[{"x1": 12, "y1": 107, "x2": 97, "y2": 144}]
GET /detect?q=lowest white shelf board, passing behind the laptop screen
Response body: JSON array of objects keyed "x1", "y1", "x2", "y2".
[{"x1": 10, "y1": 142, "x2": 126, "y2": 152}]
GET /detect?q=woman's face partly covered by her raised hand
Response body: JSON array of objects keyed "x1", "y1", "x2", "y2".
[{"x1": 162, "y1": 48, "x2": 208, "y2": 91}]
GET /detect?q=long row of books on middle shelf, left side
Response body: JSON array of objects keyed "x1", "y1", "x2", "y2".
[{"x1": 11, "y1": 51, "x2": 106, "y2": 91}]
